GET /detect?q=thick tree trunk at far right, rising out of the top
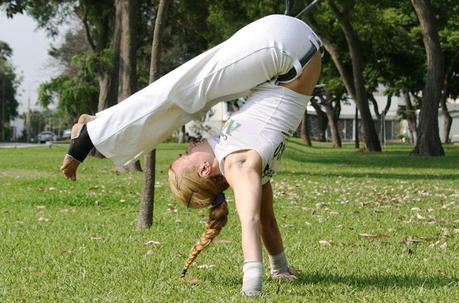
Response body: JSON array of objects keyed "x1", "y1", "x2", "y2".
[{"x1": 411, "y1": 0, "x2": 445, "y2": 156}]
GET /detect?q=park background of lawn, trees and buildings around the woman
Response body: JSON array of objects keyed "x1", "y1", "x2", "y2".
[{"x1": 0, "y1": 0, "x2": 459, "y2": 302}]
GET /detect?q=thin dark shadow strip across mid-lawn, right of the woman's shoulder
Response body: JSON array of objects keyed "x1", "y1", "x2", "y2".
[{"x1": 277, "y1": 171, "x2": 459, "y2": 181}]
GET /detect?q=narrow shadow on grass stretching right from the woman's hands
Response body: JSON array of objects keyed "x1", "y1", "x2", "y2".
[{"x1": 294, "y1": 272, "x2": 459, "y2": 289}]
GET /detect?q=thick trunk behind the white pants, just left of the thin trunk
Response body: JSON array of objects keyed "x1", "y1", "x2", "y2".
[{"x1": 116, "y1": 0, "x2": 141, "y2": 171}]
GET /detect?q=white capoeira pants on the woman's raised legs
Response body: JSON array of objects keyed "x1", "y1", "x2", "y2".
[{"x1": 87, "y1": 15, "x2": 320, "y2": 166}]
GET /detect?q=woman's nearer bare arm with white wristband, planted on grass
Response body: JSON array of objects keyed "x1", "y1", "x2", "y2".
[{"x1": 225, "y1": 150, "x2": 263, "y2": 296}]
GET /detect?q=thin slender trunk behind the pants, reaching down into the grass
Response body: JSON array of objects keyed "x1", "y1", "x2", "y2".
[{"x1": 137, "y1": 0, "x2": 171, "y2": 228}]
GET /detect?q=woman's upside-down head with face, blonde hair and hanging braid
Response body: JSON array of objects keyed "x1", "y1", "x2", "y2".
[{"x1": 169, "y1": 141, "x2": 228, "y2": 275}]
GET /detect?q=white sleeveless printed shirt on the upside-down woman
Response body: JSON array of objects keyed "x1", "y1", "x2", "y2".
[{"x1": 208, "y1": 81, "x2": 311, "y2": 184}]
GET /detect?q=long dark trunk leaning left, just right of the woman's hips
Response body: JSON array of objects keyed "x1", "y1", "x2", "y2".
[{"x1": 329, "y1": 0, "x2": 381, "y2": 152}]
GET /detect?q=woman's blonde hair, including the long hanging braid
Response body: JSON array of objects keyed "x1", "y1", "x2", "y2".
[{"x1": 169, "y1": 167, "x2": 229, "y2": 277}]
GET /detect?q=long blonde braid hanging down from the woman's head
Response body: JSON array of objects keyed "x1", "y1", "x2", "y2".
[{"x1": 182, "y1": 202, "x2": 228, "y2": 277}]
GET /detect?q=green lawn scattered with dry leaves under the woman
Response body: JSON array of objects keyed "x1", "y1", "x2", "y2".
[{"x1": 0, "y1": 140, "x2": 459, "y2": 302}]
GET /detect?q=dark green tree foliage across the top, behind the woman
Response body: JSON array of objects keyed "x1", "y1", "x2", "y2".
[{"x1": 0, "y1": 0, "x2": 459, "y2": 152}]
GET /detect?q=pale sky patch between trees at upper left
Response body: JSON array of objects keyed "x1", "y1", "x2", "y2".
[{"x1": 0, "y1": 11, "x2": 57, "y2": 113}]
